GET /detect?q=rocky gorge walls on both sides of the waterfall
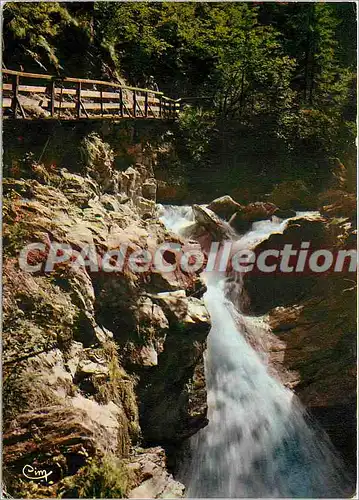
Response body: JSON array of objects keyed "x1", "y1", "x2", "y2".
[{"x1": 3, "y1": 133, "x2": 356, "y2": 498}]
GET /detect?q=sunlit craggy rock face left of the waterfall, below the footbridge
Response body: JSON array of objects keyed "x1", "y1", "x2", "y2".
[{"x1": 3, "y1": 138, "x2": 210, "y2": 498}]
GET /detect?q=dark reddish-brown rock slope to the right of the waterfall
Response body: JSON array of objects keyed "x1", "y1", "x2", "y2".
[{"x1": 244, "y1": 213, "x2": 356, "y2": 464}]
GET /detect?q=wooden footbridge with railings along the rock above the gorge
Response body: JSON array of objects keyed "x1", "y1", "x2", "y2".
[{"x1": 2, "y1": 70, "x2": 181, "y2": 120}]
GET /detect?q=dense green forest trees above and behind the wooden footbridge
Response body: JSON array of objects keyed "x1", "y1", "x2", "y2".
[{"x1": 3, "y1": 2, "x2": 356, "y2": 201}]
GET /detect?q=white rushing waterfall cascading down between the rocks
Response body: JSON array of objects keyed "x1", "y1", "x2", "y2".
[{"x1": 162, "y1": 203, "x2": 348, "y2": 498}]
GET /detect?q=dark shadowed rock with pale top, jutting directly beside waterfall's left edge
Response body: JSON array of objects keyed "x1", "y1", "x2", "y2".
[{"x1": 139, "y1": 290, "x2": 210, "y2": 443}]
